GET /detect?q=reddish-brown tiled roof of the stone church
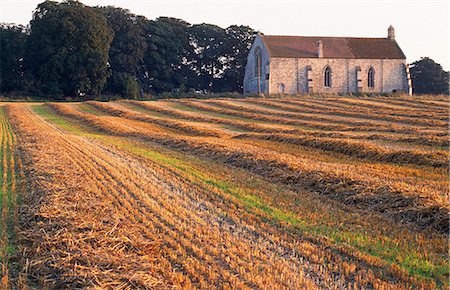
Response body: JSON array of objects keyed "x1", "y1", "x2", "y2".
[{"x1": 261, "y1": 35, "x2": 406, "y2": 59}]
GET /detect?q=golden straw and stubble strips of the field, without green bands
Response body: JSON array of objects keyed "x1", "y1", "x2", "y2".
[{"x1": 2, "y1": 95, "x2": 448, "y2": 288}]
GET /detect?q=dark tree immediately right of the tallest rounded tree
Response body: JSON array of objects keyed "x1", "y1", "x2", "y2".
[{"x1": 98, "y1": 6, "x2": 148, "y2": 98}]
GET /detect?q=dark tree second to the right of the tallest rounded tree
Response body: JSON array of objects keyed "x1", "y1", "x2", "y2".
[{"x1": 141, "y1": 17, "x2": 192, "y2": 93}]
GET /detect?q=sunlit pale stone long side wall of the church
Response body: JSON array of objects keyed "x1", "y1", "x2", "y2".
[{"x1": 269, "y1": 58, "x2": 408, "y2": 94}]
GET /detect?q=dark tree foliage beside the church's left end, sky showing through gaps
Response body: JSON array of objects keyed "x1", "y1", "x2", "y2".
[{"x1": 142, "y1": 17, "x2": 256, "y2": 93}]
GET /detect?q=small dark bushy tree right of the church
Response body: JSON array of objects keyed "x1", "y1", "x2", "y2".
[{"x1": 410, "y1": 57, "x2": 449, "y2": 94}]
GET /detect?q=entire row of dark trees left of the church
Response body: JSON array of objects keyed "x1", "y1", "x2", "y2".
[{"x1": 0, "y1": 0, "x2": 257, "y2": 99}]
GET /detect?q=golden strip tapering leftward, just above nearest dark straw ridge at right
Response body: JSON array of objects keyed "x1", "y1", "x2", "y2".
[{"x1": 240, "y1": 135, "x2": 449, "y2": 206}]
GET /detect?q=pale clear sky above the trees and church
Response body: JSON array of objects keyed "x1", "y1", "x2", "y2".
[{"x1": 0, "y1": 0, "x2": 450, "y2": 70}]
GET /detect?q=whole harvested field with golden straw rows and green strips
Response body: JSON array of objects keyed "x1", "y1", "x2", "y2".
[{"x1": 0, "y1": 97, "x2": 450, "y2": 289}]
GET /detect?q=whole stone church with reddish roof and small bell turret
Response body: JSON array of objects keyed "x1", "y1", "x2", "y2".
[{"x1": 244, "y1": 26, "x2": 411, "y2": 95}]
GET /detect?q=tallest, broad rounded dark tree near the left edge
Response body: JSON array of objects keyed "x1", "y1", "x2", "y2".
[{"x1": 25, "y1": 0, "x2": 112, "y2": 97}]
